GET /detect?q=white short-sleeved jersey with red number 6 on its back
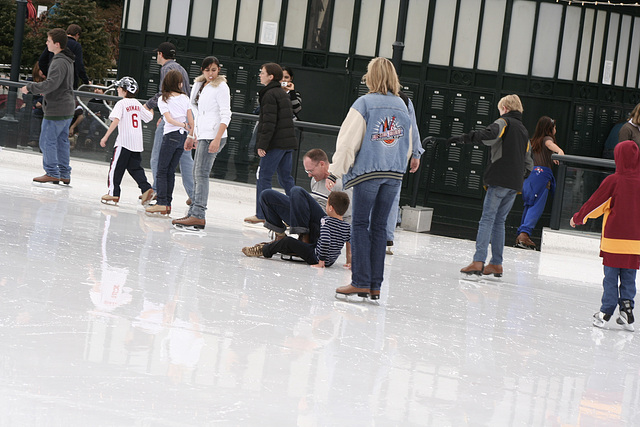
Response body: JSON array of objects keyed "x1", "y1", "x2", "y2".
[{"x1": 109, "y1": 98, "x2": 153, "y2": 153}]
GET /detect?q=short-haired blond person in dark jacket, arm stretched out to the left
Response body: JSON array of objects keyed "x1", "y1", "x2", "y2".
[{"x1": 452, "y1": 95, "x2": 533, "y2": 277}]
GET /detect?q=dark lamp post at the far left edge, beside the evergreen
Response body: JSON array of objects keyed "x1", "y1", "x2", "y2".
[{"x1": 1, "y1": 0, "x2": 27, "y2": 146}]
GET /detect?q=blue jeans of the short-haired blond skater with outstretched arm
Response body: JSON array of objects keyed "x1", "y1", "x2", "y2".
[{"x1": 473, "y1": 185, "x2": 517, "y2": 265}]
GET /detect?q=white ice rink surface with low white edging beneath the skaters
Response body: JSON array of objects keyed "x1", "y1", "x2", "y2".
[{"x1": 0, "y1": 149, "x2": 640, "y2": 427}]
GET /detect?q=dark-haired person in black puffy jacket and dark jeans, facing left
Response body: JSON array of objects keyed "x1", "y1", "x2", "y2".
[{"x1": 244, "y1": 62, "x2": 298, "y2": 224}]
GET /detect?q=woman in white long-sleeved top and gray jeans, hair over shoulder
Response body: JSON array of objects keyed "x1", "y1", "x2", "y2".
[{"x1": 173, "y1": 56, "x2": 231, "y2": 231}]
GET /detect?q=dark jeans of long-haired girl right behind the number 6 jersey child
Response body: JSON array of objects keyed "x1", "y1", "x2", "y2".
[{"x1": 156, "y1": 130, "x2": 187, "y2": 206}]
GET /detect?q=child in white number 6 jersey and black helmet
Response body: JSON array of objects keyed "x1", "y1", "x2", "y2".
[{"x1": 100, "y1": 77, "x2": 153, "y2": 206}]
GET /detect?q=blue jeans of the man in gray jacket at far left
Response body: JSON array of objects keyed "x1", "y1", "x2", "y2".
[{"x1": 40, "y1": 119, "x2": 71, "y2": 178}]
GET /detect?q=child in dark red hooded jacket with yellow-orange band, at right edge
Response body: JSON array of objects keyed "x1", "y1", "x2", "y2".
[{"x1": 569, "y1": 141, "x2": 640, "y2": 331}]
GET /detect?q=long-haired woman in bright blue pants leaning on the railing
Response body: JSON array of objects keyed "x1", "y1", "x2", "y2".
[{"x1": 516, "y1": 116, "x2": 564, "y2": 249}]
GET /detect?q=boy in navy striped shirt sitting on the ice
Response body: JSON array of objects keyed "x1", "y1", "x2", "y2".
[{"x1": 242, "y1": 191, "x2": 351, "y2": 268}]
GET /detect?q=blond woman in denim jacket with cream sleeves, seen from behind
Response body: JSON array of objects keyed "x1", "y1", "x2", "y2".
[{"x1": 327, "y1": 57, "x2": 420, "y2": 300}]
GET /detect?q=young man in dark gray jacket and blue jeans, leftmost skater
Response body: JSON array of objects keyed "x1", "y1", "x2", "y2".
[{"x1": 21, "y1": 28, "x2": 75, "y2": 184}]
